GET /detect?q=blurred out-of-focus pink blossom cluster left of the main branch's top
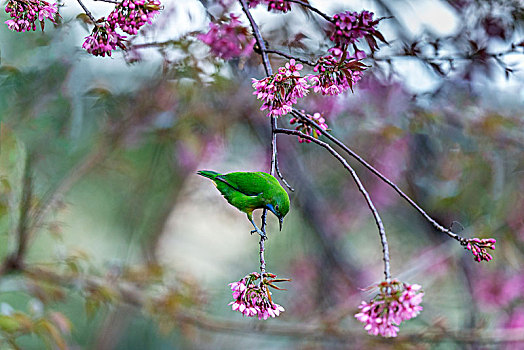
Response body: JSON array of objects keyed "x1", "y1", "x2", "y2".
[{"x1": 198, "y1": 14, "x2": 255, "y2": 60}]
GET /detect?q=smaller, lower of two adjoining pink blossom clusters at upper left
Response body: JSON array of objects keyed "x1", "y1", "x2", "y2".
[{"x1": 82, "y1": 22, "x2": 126, "y2": 57}]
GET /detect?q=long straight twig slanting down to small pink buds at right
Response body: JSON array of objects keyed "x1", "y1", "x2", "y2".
[{"x1": 291, "y1": 110, "x2": 467, "y2": 245}]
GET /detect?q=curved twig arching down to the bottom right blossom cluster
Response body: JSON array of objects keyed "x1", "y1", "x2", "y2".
[{"x1": 275, "y1": 129, "x2": 391, "y2": 282}]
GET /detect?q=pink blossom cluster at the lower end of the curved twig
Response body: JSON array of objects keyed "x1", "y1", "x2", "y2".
[{"x1": 355, "y1": 280, "x2": 424, "y2": 337}]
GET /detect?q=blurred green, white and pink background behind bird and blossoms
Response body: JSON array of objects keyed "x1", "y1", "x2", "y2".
[{"x1": 0, "y1": 0, "x2": 524, "y2": 349}]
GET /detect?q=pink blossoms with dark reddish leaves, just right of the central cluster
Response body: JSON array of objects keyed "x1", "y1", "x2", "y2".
[{"x1": 309, "y1": 48, "x2": 367, "y2": 96}]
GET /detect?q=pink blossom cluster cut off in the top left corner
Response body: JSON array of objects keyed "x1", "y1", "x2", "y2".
[{"x1": 5, "y1": 0, "x2": 58, "y2": 32}]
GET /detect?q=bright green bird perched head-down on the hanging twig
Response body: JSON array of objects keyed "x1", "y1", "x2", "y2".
[{"x1": 197, "y1": 170, "x2": 289, "y2": 237}]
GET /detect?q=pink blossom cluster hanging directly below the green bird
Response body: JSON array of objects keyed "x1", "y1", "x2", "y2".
[{"x1": 229, "y1": 272, "x2": 289, "y2": 320}]
